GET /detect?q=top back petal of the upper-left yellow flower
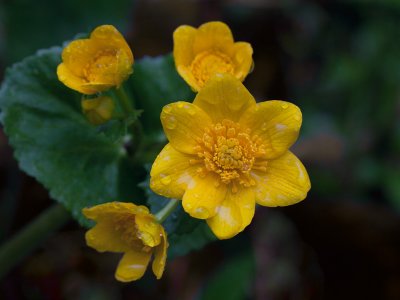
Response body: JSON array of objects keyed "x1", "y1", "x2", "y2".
[{"x1": 90, "y1": 25, "x2": 133, "y2": 64}]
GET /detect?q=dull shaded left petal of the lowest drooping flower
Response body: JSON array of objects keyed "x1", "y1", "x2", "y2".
[{"x1": 85, "y1": 216, "x2": 129, "y2": 252}]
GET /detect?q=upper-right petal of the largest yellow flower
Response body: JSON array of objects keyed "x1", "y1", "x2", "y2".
[{"x1": 240, "y1": 100, "x2": 302, "y2": 159}]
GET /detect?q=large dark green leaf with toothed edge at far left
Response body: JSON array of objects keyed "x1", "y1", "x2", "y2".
[{"x1": 0, "y1": 47, "x2": 143, "y2": 225}]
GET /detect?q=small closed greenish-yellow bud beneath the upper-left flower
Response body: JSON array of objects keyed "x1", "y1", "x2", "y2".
[{"x1": 81, "y1": 96, "x2": 115, "y2": 125}]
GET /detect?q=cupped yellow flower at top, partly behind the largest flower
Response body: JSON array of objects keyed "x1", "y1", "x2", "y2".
[{"x1": 174, "y1": 22, "x2": 253, "y2": 91}]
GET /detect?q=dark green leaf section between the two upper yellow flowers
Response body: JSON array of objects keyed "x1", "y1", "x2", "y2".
[{"x1": 129, "y1": 54, "x2": 194, "y2": 132}]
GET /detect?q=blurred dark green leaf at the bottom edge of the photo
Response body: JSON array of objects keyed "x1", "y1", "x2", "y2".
[{"x1": 201, "y1": 252, "x2": 255, "y2": 300}]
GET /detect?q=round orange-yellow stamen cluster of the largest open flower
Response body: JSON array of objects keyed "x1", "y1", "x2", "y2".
[{"x1": 191, "y1": 119, "x2": 266, "y2": 191}]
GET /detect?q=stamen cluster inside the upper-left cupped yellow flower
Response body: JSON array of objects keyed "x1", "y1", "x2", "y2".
[{"x1": 83, "y1": 49, "x2": 118, "y2": 83}]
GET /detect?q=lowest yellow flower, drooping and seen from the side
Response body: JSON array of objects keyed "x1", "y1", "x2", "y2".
[{"x1": 82, "y1": 202, "x2": 168, "y2": 282}]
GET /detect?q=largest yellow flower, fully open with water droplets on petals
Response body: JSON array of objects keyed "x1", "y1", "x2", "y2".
[{"x1": 150, "y1": 74, "x2": 311, "y2": 239}]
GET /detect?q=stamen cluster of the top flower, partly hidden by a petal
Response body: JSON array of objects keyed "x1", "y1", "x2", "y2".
[{"x1": 190, "y1": 50, "x2": 234, "y2": 87}]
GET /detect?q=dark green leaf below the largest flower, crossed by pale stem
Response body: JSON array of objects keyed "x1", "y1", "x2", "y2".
[{"x1": 141, "y1": 175, "x2": 216, "y2": 258}]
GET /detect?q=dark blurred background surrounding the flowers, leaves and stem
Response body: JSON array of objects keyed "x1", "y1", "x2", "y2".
[{"x1": 0, "y1": 0, "x2": 400, "y2": 300}]
